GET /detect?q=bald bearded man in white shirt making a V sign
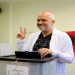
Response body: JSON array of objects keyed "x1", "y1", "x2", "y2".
[{"x1": 17, "y1": 11, "x2": 74, "y2": 75}]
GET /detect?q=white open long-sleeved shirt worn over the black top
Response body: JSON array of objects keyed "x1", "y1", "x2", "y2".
[{"x1": 17, "y1": 28, "x2": 74, "y2": 75}]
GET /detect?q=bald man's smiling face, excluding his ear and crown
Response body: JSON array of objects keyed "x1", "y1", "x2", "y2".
[{"x1": 37, "y1": 14, "x2": 53, "y2": 32}]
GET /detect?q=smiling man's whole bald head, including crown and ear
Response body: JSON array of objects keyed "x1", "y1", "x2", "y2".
[{"x1": 37, "y1": 12, "x2": 55, "y2": 32}]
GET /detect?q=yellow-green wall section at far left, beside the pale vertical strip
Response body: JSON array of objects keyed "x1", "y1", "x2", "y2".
[{"x1": 0, "y1": 3, "x2": 10, "y2": 42}]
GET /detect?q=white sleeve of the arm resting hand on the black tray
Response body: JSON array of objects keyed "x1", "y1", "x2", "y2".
[{"x1": 53, "y1": 32, "x2": 74, "y2": 63}]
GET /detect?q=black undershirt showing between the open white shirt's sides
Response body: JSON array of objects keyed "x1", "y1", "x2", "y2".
[{"x1": 33, "y1": 33, "x2": 52, "y2": 51}]
